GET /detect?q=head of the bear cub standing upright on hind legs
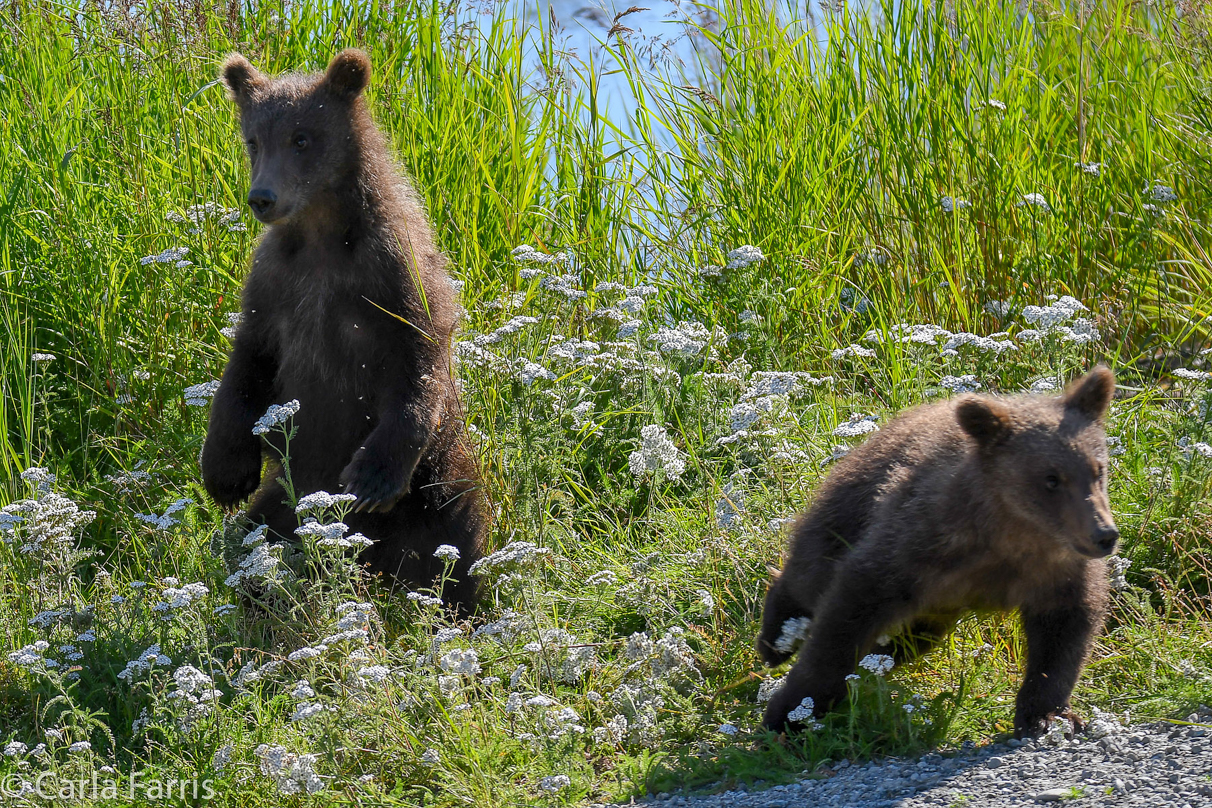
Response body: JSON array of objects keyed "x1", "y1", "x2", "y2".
[{"x1": 223, "y1": 50, "x2": 371, "y2": 224}]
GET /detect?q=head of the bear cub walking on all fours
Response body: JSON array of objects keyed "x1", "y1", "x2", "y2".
[{"x1": 955, "y1": 366, "x2": 1120, "y2": 558}]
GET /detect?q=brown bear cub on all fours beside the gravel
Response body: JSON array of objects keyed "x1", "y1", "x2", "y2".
[{"x1": 758, "y1": 367, "x2": 1119, "y2": 737}]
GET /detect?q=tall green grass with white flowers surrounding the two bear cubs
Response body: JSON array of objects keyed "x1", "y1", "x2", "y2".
[{"x1": 0, "y1": 0, "x2": 1212, "y2": 806}]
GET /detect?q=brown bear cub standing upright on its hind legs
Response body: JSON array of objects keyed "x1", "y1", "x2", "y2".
[{"x1": 201, "y1": 50, "x2": 486, "y2": 607}]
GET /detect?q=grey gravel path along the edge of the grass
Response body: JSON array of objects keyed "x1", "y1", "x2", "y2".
[{"x1": 610, "y1": 707, "x2": 1212, "y2": 808}]
